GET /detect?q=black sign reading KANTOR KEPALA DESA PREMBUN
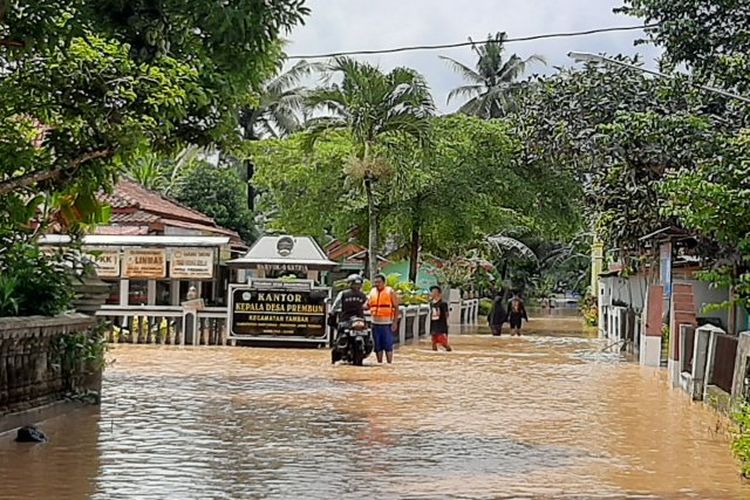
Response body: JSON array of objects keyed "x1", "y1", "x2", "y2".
[{"x1": 230, "y1": 287, "x2": 326, "y2": 338}]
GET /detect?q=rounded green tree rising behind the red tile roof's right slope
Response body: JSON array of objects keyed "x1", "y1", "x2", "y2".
[{"x1": 176, "y1": 162, "x2": 257, "y2": 242}]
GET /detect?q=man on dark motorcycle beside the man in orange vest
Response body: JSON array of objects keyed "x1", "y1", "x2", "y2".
[{"x1": 331, "y1": 274, "x2": 372, "y2": 364}]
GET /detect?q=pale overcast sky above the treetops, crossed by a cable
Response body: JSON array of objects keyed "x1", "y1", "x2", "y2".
[{"x1": 287, "y1": 0, "x2": 658, "y2": 111}]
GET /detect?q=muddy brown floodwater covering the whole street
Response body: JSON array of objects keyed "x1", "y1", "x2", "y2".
[{"x1": 0, "y1": 319, "x2": 750, "y2": 499}]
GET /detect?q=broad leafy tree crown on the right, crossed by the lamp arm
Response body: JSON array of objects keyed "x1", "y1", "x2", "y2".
[{"x1": 509, "y1": 56, "x2": 737, "y2": 253}]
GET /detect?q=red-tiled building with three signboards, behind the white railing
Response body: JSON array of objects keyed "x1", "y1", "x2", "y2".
[{"x1": 41, "y1": 178, "x2": 247, "y2": 306}]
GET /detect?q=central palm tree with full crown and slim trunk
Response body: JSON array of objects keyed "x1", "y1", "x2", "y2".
[{"x1": 307, "y1": 57, "x2": 435, "y2": 277}]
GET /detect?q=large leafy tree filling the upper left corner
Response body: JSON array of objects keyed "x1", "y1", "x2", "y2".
[{"x1": 0, "y1": 0, "x2": 307, "y2": 232}]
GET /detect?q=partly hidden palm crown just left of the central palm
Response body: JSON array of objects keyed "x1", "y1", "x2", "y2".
[{"x1": 240, "y1": 61, "x2": 321, "y2": 141}]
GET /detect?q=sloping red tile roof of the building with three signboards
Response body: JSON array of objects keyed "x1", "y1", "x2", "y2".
[{"x1": 96, "y1": 178, "x2": 245, "y2": 246}]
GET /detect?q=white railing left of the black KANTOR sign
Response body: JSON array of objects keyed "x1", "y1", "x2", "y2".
[{"x1": 96, "y1": 306, "x2": 227, "y2": 346}]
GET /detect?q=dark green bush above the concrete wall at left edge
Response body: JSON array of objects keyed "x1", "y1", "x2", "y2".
[{"x1": 0, "y1": 241, "x2": 74, "y2": 316}]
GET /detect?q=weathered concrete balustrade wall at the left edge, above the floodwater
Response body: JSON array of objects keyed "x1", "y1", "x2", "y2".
[{"x1": 0, "y1": 314, "x2": 101, "y2": 432}]
